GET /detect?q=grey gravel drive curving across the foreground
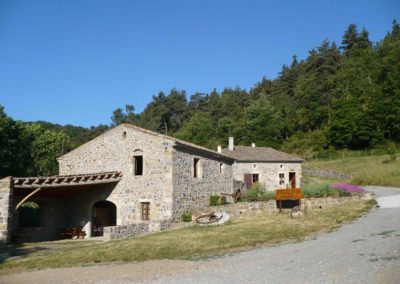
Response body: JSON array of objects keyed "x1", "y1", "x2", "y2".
[{"x1": 0, "y1": 187, "x2": 400, "y2": 283}]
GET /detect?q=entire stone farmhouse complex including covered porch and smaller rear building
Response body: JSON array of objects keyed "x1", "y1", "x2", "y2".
[{"x1": 0, "y1": 124, "x2": 302, "y2": 243}]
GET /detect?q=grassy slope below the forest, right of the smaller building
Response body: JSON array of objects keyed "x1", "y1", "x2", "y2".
[{"x1": 304, "y1": 155, "x2": 400, "y2": 187}]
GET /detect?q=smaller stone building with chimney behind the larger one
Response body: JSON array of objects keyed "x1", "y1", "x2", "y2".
[{"x1": 218, "y1": 137, "x2": 304, "y2": 191}]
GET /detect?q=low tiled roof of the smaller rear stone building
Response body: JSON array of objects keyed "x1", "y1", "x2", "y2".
[{"x1": 222, "y1": 146, "x2": 304, "y2": 163}]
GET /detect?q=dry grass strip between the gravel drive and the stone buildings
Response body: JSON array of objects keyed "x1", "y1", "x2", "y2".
[{"x1": 0, "y1": 201, "x2": 374, "y2": 273}]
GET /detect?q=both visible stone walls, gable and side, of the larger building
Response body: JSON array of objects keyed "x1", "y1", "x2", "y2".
[{"x1": 59, "y1": 125, "x2": 233, "y2": 231}]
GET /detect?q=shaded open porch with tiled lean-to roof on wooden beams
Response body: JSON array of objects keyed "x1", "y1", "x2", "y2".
[{"x1": 8, "y1": 172, "x2": 122, "y2": 242}]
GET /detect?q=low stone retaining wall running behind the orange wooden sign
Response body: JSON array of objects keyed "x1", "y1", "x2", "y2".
[{"x1": 190, "y1": 194, "x2": 371, "y2": 220}]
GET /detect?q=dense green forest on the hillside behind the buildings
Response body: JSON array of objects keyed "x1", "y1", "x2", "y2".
[{"x1": 0, "y1": 21, "x2": 400, "y2": 176}]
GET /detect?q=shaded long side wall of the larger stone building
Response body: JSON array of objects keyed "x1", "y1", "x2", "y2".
[{"x1": 173, "y1": 150, "x2": 233, "y2": 220}]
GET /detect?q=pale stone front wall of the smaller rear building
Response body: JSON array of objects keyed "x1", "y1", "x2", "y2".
[{"x1": 233, "y1": 162, "x2": 302, "y2": 191}]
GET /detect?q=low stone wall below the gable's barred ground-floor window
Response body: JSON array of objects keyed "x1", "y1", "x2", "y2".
[{"x1": 103, "y1": 221, "x2": 171, "y2": 241}]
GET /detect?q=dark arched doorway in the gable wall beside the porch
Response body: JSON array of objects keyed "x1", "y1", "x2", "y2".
[{"x1": 92, "y1": 200, "x2": 117, "y2": 237}]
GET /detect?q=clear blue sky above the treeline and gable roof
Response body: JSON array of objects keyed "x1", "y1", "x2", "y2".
[{"x1": 0, "y1": 0, "x2": 400, "y2": 126}]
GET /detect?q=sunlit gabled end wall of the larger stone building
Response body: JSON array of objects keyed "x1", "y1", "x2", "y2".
[{"x1": 59, "y1": 125, "x2": 174, "y2": 228}]
